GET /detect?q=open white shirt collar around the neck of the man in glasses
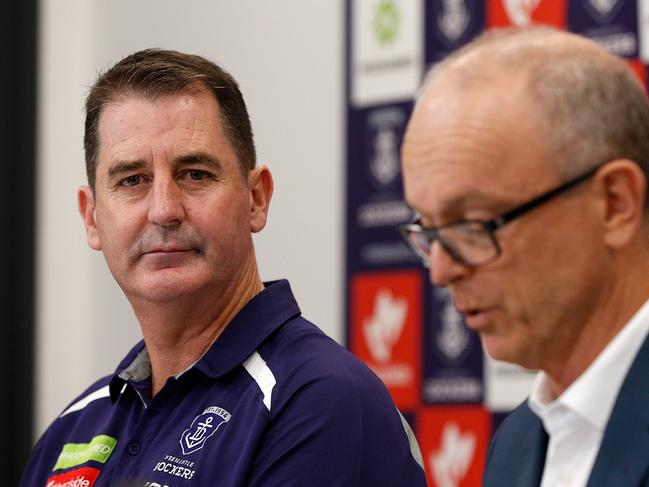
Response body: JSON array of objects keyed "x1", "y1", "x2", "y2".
[{"x1": 528, "y1": 300, "x2": 649, "y2": 431}]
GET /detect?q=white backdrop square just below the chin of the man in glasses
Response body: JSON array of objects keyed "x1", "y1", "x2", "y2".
[{"x1": 484, "y1": 353, "x2": 536, "y2": 411}]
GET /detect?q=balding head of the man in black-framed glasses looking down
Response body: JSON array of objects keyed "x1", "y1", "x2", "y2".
[{"x1": 402, "y1": 28, "x2": 649, "y2": 374}]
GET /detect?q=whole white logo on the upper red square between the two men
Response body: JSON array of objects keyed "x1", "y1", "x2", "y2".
[{"x1": 363, "y1": 288, "x2": 408, "y2": 362}]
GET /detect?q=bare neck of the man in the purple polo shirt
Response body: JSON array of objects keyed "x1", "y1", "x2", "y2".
[{"x1": 133, "y1": 258, "x2": 264, "y2": 396}]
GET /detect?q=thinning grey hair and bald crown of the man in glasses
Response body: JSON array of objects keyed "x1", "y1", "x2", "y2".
[{"x1": 422, "y1": 27, "x2": 649, "y2": 194}]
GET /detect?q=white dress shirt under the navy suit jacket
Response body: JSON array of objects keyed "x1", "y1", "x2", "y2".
[{"x1": 528, "y1": 301, "x2": 649, "y2": 487}]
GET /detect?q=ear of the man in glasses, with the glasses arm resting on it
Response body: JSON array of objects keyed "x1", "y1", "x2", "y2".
[{"x1": 595, "y1": 159, "x2": 647, "y2": 248}]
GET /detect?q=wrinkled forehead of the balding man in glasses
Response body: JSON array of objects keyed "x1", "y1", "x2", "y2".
[{"x1": 402, "y1": 79, "x2": 558, "y2": 219}]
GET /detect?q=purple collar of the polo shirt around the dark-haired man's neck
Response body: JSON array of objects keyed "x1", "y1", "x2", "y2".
[{"x1": 110, "y1": 280, "x2": 301, "y2": 400}]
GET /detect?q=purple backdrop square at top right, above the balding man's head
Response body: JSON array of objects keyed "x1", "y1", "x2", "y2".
[{"x1": 568, "y1": 0, "x2": 642, "y2": 58}]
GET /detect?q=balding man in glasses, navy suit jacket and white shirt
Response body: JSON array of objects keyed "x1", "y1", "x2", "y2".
[{"x1": 400, "y1": 27, "x2": 649, "y2": 487}]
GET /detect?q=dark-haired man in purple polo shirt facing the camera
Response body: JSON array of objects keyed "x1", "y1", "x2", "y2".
[{"x1": 21, "y1": 50, "x2": 426, "y2": 487}]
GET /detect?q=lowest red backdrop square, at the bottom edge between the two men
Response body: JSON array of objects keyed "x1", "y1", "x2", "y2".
[{"x1": 417, "y1": 406, "x2": 491, "y2": 487}]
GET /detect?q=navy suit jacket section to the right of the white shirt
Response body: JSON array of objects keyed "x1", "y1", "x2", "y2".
[{"x1": 588, "y1": 337, "x2": 649, "y2": 487}]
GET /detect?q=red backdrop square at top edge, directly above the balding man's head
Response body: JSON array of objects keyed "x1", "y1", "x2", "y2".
[{"x1": 487, "y1": 0, "x2": 566, "y2": 28}]
